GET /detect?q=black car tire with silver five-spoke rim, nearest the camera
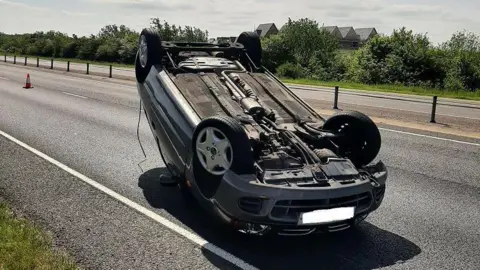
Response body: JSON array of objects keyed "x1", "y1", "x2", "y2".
[{"x1": 192, "y1": 116, "x2": 255, "y2": 198}]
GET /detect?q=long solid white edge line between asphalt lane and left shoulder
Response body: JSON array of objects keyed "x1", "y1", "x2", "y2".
[{"x1": 0, "y1": 130, "x2": 257, "y2": 269}]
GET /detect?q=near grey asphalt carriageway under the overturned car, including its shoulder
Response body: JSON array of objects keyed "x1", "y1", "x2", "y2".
[{"x1": 0, "y1": 66, "x2": 480, "y2": 269}]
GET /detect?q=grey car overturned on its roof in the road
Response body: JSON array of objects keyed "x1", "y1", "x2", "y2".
[{"x1": 135, "y1": 29, "x2": 387, "y2": 235}]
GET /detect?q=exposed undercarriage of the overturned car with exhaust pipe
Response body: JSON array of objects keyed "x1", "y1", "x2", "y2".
[{"x1": 169, "y1": 56, "x2": 384, "y2": 187}]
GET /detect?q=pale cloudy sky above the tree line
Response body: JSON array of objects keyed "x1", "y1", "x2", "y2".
[{"x1": 0, "y1": 0, "x2": 480, "y2": 43}]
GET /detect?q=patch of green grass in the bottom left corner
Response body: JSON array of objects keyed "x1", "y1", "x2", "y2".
[{"x1": 0, "y1": 203, "x2": 76, "y2": 270}]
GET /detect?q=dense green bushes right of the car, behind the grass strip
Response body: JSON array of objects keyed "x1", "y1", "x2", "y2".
[{"x1": 263, "y1": 19, "x2": 480, "y2": 91}]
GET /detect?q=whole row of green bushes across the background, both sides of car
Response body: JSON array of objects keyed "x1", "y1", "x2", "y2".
[{"x1": 0, "y1": 18, "x2": 480, "y2": 94}]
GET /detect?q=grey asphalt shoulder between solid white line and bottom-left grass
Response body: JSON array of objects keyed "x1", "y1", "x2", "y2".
[{"x1": 0, "y1": 136, "x2": 221, "y2": 269}]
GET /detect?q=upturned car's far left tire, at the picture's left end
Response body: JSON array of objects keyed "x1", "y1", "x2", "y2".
[{"x1": 135, "y1": 28, "x2": 164, "y2": 83}]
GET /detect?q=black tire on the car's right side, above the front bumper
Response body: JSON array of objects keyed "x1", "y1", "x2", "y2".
[{"x1": 323, "y1": 111, "x2": 382, "y2": 167}]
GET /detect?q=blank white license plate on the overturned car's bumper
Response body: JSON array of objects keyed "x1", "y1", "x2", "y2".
[{"x1": 298, "y1": 207, "x2": 355, "y2": 225}]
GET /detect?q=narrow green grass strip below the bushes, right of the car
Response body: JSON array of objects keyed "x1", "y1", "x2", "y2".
[{"x1": 282, "y1": 78, "x2": 480, "y2": 101}]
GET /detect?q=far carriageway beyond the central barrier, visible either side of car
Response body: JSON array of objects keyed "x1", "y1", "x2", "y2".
[{"x1": 3, "y1": 57, "x2": 480, "y2": 120}]
